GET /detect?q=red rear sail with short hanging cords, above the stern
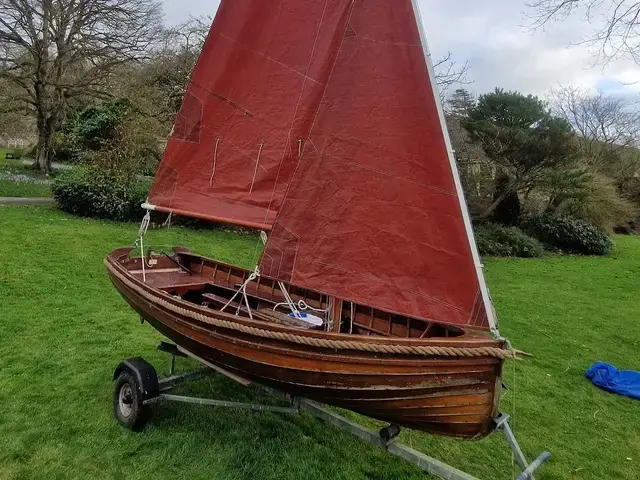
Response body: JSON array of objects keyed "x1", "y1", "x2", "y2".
[{"x1": 149, "y1": 0, "x2": 351, "y2": 230}]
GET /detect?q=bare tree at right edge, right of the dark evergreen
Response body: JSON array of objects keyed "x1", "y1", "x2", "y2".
[{"x1": 549, "y1": 86, "x2": 640, "y2": 169}]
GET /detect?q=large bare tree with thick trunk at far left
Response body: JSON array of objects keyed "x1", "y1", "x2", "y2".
[{"x1": 0, "y1": 0, "x2": 161, "y2": 172}]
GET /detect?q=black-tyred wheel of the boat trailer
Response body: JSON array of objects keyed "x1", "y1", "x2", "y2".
[{"x1": 113, "y1": 370, "x2": 148, "y2": 430}]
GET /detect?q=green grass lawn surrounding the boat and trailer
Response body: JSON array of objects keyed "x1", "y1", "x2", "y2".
[{"x1": 0, "y1": 207, "x2": 640, "y2": 480}]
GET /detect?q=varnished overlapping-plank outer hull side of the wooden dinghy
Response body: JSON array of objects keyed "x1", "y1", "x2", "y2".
[{"x1": 105, "y1": 250, "x2": 503, "y2": 439}]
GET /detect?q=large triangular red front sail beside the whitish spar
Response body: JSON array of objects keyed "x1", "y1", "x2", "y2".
[{"x1": 260, "y1": 0, "x2": 492, "y2": 329}]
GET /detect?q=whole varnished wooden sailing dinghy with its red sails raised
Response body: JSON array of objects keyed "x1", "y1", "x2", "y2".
[{"x1": 106, "y1": 0, "x2": 514, "y2": 439}]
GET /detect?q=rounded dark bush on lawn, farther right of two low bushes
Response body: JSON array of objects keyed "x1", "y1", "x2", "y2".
[{"x1": 521, "y1": 214, "x2": 613, "y2": 255}]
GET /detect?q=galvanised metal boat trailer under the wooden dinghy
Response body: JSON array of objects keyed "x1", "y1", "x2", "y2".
[{"x1": 113, "y1": 342, "x2": 551, "y2": 480}]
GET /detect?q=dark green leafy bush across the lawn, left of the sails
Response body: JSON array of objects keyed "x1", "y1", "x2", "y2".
[{"x1": 52, "y1": 167, "x2": 151, "y2": 221}]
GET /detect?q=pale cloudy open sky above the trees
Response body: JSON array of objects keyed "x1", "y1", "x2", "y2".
[{"x1": 164, "y1": 0, "x2": 640, "y2": 99}]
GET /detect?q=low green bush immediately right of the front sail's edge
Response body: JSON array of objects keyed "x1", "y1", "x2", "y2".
[{"x1": 476, "y1": 223, "x2": 544, "y2": 258}]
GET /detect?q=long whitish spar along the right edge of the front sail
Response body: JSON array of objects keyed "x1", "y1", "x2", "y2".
[{"x1": 411, "y1": 0, "x2": 499, "y2": 336}]
